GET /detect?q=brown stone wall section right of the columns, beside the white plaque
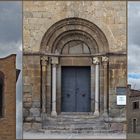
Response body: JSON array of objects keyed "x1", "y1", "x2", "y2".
[{"x1": 109, "y1": 56, "x2": 127, "y2": 117}]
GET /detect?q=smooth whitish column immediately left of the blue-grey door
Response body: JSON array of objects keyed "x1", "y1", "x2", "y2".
[{"x1": 51, "y1": 57, "x2": 58, "y2": 116}]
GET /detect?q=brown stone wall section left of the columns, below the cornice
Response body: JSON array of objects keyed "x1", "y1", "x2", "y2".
[{"x1": 23, "y1": 56, "x2": 41, "y2": 130}]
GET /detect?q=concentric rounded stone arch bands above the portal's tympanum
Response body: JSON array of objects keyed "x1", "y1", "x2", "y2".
[{"x1": 40, "y1": 18, "x2": 109, "y2": 54}]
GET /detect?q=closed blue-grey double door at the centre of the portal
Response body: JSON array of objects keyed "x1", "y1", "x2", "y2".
[{"x1": 61, "y1": 67, "x2": 91, "y2": 112}]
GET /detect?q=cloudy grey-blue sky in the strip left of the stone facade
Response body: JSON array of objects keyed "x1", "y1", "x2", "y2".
[{"x1": 0, "y1": 1, "x2": 22, "y2": 139}]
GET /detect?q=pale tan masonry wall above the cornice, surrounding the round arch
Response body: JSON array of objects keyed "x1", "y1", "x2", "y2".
[{"x1": 23, "y1": 1, "x2": 126, "y2": 52}]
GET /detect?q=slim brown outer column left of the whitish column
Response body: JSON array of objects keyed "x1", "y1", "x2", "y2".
[{"x1": 41, "y1": 56, "x2": 48, "y2": 113}]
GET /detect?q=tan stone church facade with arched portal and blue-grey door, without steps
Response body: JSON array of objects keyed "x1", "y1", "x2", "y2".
[{"x1": 23, "y1": 1, "x2": 127, "y2": 131}]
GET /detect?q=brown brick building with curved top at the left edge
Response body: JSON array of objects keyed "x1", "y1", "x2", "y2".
[{"x1": 0, "y1": 55, "x2": 16, "y2": 140}]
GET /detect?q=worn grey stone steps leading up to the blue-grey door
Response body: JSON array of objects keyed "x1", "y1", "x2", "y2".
[{"x1": 43, "y1": 115, "x2": 114, "y2": 134}]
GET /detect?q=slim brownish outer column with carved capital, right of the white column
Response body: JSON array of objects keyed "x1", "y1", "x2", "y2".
[{"x1": 102, "y1": 56, "x2": 108, "y2": 117}]
